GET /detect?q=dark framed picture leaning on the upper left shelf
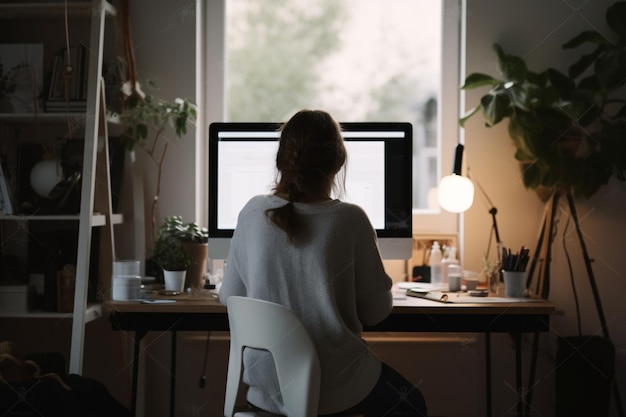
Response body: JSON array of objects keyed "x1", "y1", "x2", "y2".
[{"x1": 0, "y1": 43, "x2": 44, "y2": 113}]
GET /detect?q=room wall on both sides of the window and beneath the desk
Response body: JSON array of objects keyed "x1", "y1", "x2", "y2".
[{"x1": 105, "y1": 0, "x2": 626, "y2": 417}]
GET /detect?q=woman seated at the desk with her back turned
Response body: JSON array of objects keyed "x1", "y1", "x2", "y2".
[{"x1": 219, "y1": 110, "x2": 426, "y2": 417}]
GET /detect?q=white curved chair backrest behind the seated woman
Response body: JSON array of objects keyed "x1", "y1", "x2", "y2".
[{"x1": 224, "y1": 296, "x2": 320, "y2": 417}]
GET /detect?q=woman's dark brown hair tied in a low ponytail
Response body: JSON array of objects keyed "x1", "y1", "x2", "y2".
[{"x1": 266, "y1": 110, "x2": 346, "y2": 242}]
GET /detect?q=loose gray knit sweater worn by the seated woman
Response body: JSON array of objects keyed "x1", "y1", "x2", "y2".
[{"x1": 219, "y1": 195, "x2": 392, "y2": 414}]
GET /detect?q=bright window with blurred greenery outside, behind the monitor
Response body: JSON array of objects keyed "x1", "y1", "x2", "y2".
[{"x1": 204, "y1": 0, "x2": 461, "y2": 226}]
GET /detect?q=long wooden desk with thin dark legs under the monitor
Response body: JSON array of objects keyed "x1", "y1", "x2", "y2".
[{"x1": 107, "y1": 289, "x2": 555, "y2": 416}]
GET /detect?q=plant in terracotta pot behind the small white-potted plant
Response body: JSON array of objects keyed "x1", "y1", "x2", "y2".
[{"x1": 155, "y1": 216, "x2": 209, "y2": 289}]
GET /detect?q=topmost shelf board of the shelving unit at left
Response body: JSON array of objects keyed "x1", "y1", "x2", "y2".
[{"x1": 0, "y1": 1, "x2": 117, "y2": 20}]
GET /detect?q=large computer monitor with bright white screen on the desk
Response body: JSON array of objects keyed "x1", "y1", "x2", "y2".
[{"x1": 208, "y1": 122, "x2": 413, "y2": 259}]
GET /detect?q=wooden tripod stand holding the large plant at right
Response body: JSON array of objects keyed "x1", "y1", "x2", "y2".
[{"x1": 524, "y1": 191, "x2": 624, "y2": 417}]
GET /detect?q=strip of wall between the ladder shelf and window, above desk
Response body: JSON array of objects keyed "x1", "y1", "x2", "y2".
[{"x1": 122, "y1": 0, "x2": 197, "y2": 259}]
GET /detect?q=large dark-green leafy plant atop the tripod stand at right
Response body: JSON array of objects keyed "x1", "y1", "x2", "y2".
[{"x1": 460, "y1": 2, "x2": 626, "y2": 199}]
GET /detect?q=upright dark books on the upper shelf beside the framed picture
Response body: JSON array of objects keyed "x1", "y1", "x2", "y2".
[{"x1": 45, "y1": 44, "x2": 89, "y2": 113}]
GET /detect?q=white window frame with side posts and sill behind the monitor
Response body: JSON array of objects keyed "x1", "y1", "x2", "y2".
[{"x1": 196, "y1": 0, "x2": 465, "y2": 234}]
